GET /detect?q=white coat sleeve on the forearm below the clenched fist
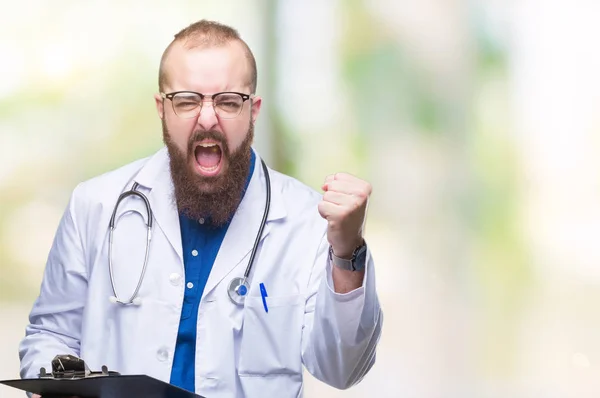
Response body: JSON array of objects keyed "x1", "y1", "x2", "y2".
[{"x1": 302, "y1": 232, "x2": 383, "y2": 389}]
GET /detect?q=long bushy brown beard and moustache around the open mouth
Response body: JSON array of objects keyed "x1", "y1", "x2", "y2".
[{"x1": 162, "y1": 120, "x2": 254, "y2": 226}]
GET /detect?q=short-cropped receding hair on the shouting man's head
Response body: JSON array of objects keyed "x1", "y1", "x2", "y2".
[{"x1": 158, "y1": 19, "x2": 258, "y2": 94}]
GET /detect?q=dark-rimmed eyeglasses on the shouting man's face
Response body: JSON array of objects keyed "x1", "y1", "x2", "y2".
[{"x1": 160, "y1": 91, "x2": 253, "y2": 119}]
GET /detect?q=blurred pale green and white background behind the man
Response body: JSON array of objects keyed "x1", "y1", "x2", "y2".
[{"x1": 0, "y1": 0, "x2": 600, "y2": 398}]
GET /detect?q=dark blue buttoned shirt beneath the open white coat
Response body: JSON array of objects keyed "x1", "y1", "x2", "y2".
[{"x1": 170, "y1": 151, "x2": 256, "y2": 392}]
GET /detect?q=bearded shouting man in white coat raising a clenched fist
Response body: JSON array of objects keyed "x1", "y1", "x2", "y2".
[{"x1": 20, "y1": 20, "x2": 382, "y2": 398}]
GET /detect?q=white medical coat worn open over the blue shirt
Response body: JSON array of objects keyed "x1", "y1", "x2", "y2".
[{"x1": 19, "y1": 148, "x2": 382, "y2": 398}]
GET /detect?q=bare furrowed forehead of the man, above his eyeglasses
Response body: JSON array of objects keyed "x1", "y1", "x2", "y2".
[{"x1": 163, "y1": 41, "x2": 250, "y2": 94}]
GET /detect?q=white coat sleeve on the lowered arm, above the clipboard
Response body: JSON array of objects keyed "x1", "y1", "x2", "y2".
[{"x1": 19, "y1": 187, "x2": 87, "y2": 378}]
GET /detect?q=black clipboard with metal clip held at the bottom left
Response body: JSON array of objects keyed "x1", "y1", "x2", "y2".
[{"x1": 0, "y1": 356, "x2": 204, "y2": 398}]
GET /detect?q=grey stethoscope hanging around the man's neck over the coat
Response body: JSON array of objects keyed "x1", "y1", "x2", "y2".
[{"x1": 108, "y1": 159, "x2": 271, "y2": 305}]
